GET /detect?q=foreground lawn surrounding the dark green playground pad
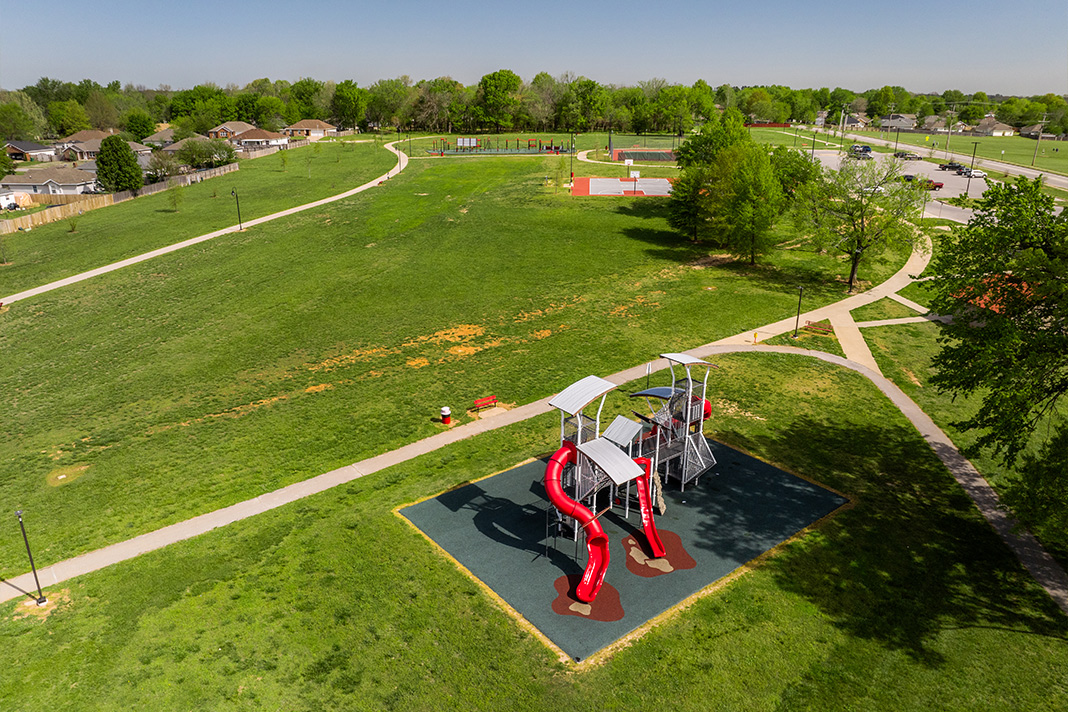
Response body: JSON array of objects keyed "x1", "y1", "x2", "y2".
[{"x1": 0, "y1": 354, "x2": 1068, "y2": 712}]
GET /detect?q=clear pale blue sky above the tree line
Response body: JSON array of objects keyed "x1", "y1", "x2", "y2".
[{"x1": 0, "y1": 0, "x2": 1068, "y2": 95}]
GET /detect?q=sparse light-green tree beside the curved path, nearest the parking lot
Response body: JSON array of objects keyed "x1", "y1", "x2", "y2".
[{"x1": 795, "y1": 160, "x2": 922, "y2": 292}]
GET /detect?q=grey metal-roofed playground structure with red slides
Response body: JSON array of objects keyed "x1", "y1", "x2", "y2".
[{"x1": 545, "y1": 353, "x2": 716, "y2": 603}]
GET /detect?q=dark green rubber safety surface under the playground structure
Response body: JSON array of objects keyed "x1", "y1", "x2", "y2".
[{"x1": 401, "y1": 442, "x2": 848, "y2": 660}]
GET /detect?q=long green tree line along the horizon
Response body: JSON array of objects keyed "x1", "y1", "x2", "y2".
[{"x1": 0, "y1": 74, "x2": 1068, "y2": 140}]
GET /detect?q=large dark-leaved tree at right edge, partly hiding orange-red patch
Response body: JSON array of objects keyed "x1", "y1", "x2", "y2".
[{"x1": 931, "y1": 177, "x2": 1068, "y2": 462}]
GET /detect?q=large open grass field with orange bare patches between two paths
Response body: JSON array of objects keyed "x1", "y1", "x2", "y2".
[{"x1": 0, "y1": 150, "x2": 905, "y2": 575}]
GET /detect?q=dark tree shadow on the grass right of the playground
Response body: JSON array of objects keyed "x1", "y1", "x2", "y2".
[{"x1": 723, "y1": 417, "x2": 1068, "y2": 667}]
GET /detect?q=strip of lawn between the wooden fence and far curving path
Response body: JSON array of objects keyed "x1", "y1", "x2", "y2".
[{"x1": 0, "y1": 142, "x2": 397, "y2": 298}]
